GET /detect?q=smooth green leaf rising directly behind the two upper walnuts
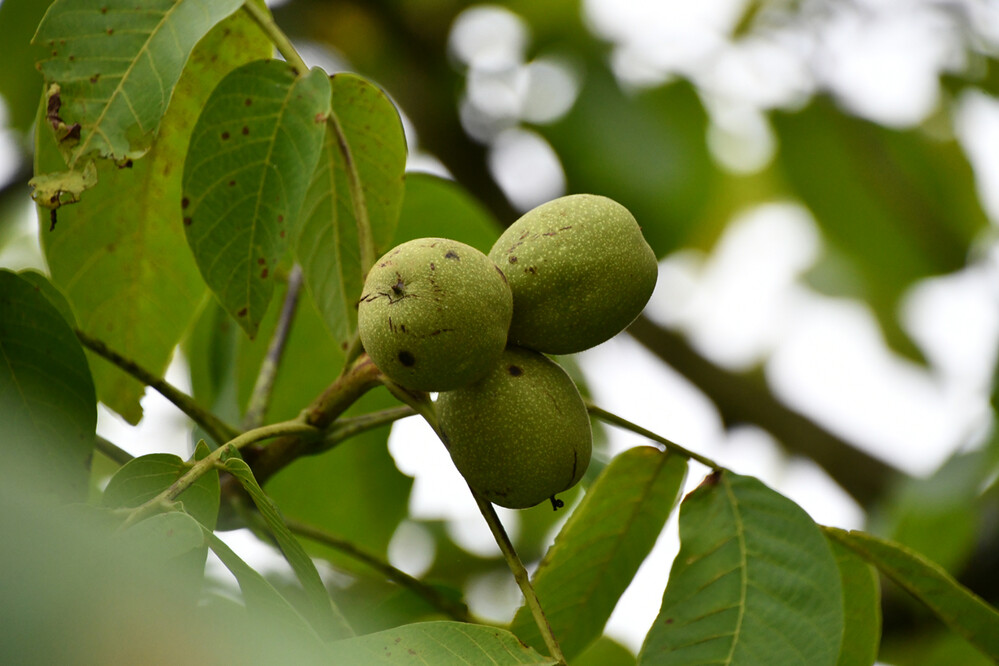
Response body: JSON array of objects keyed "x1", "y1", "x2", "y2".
[{"x1": 392, "y1": 173, "x2": 503, "y2": 254}]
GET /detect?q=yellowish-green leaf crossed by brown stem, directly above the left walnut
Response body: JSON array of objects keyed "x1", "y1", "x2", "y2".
[{"x1": 297, "y1": 74, "x2": 406, "y2": 348}]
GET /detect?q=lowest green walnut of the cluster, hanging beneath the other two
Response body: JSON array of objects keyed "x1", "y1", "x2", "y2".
[{"x1": 436, "y1": 347, "x2": 593, "y2": 509}]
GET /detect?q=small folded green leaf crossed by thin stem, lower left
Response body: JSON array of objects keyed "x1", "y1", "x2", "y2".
[{"x1": 101, "y1": 442, "x2": 220, "y2": 529}]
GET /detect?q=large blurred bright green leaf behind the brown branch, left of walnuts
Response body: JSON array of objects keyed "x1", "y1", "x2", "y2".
[{"x1": 238, "y1": 282, "x2": 412, "y2": 567}]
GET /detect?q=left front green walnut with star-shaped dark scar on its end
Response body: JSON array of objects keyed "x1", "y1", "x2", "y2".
[{"x1": 357, "y1": 238, "x2": 513, "y2": 391}]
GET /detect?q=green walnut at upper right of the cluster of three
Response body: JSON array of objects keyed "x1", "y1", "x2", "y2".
[{"x1": 489, "y1": 194, "x2": 658, "y2": 354}]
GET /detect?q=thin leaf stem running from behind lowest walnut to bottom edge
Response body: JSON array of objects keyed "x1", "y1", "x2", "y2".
[{"x1": 385, "y1": 380, "x2": 566, "y2": 665}]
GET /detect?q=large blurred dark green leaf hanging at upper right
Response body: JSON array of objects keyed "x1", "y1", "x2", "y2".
[{"x1": 773, "y1": 99, "x2": 988, "y2": 358}]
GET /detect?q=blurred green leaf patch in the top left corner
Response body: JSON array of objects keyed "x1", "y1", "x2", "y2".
[{"x1": 0, "y1": 0, "x2": 51, "y2": 132}]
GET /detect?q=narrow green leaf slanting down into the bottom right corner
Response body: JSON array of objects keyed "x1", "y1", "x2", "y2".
[{"x1": 826, "y1": 527, "x2": 999, "y2": 660}]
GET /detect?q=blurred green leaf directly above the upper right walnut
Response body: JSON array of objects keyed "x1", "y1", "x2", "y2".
[{"x1": 538, "y1": 70, "x2": 718, "y2": 257}]
